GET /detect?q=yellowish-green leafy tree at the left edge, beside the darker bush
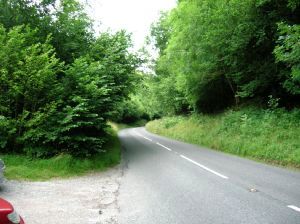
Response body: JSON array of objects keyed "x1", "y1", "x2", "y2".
[{"x1": 0, "y1": 26, "x2": 61, "y2": 153}]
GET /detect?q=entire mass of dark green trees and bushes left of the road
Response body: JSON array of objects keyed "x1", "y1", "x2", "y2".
[{"x1": 0, "y1": 0, "x2": 139, "y2": 157}]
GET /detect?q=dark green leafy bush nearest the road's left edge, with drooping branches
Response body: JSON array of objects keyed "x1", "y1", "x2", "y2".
[{"x1": 18, "y1": 31, "x2": 139, "y2": 157}]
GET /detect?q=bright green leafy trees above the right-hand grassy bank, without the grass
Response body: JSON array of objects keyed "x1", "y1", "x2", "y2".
[{"x1": 141, "y1": 0, "x2": 300, "y2": 116}]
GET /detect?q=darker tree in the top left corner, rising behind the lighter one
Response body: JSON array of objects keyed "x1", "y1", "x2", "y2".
[{"x1": 0, "y1": 0, "x2": 94, "y2": 64}]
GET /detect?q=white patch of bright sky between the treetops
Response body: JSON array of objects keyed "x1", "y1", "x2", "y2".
[{"x1": 82, "y1": 0, "x2": 176, "y2": 49}]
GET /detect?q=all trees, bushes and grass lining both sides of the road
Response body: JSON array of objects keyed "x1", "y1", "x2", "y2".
[{"x1": 0, "y1": 0, "x2": 300, "y2": 179}]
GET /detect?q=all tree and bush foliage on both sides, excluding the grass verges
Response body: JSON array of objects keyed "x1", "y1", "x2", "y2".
[{"x1": 0, "y1": 0, "x2": 300, "y2": 161}]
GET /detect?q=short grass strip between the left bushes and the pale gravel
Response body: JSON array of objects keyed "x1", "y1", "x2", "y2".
[{"x1": 0, "y1": 130, "x2": 121, "y2": 181}]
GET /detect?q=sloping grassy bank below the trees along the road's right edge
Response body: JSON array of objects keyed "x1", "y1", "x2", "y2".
[{"x1": 146, "y1": 108, "x2": 300, "y2": 168}]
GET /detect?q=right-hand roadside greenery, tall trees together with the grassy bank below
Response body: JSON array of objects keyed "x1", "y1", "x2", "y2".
[{"x1": 136, "y1": 0, "x2": 300, "y2": 167}]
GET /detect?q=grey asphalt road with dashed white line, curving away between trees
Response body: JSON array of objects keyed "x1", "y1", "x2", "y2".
[{"x1": 119, "y1": 128, "x2": 300, "y2": 224}]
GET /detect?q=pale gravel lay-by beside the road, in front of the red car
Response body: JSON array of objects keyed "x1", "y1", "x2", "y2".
[{"x1": 0, "y1": 166, "x2": 122, "y2": 224}]
